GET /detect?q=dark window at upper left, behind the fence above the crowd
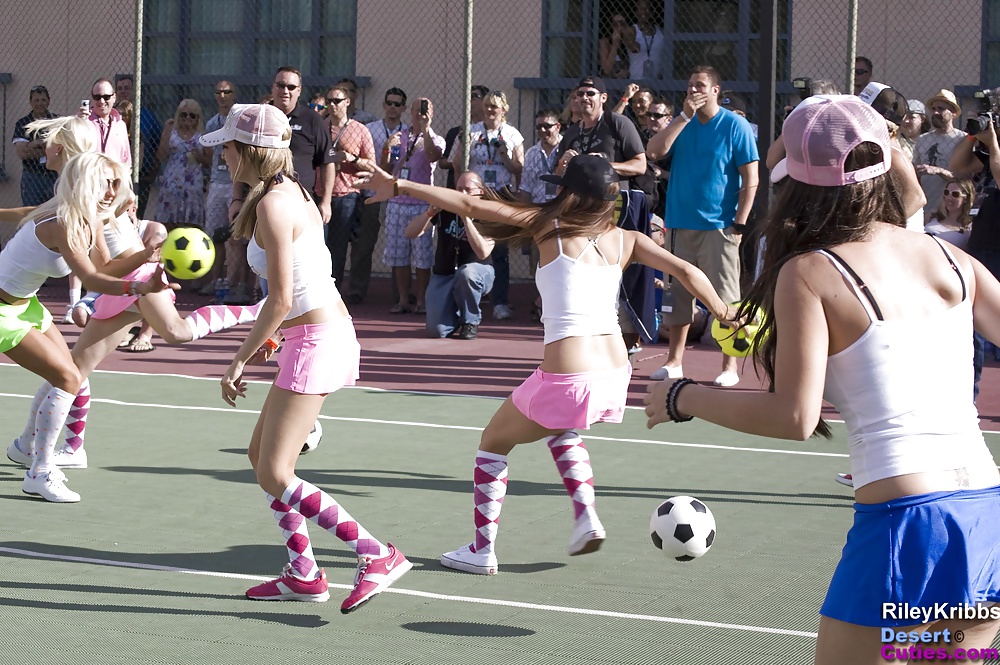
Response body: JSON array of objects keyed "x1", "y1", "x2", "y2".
[{"x1": 142, "y1": 0, "x2": 357, "y2": 117}]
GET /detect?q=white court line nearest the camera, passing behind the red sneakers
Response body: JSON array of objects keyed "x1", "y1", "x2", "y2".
[{"x1": 0, "y1": 547, "x2": 816, "y2": 639}]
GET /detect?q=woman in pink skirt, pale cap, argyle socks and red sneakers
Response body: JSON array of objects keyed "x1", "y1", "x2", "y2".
[{"x1": 201, "y1": 104, "x2": 412, "y2": 614}]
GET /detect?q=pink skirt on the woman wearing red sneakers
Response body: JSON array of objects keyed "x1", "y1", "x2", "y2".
[{"x1": 274, "y1": 317, "x2": 361, "y2": 395}]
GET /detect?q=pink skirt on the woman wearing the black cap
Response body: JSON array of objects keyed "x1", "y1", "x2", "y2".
[{"x1": 511, "y1": 365, "x2": 632, "y2": 430}]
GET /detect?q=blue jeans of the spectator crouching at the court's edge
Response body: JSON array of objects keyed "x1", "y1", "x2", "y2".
[{"x1": 425, "y1": 263, "x2": 494, "y2": 337}]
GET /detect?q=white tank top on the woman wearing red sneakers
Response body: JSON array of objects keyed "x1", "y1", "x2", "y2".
[{"x1": 247, "y1": 209, "x2": 340, "y2": 321}]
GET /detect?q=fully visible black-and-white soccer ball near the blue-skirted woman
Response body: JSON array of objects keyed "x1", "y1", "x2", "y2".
[{"x1": 649, "y1": 496, "x2": 715, "y2": 561}]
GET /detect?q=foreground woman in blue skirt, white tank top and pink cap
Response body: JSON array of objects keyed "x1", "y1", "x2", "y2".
[{"x1": 646, "y1": 96, "x2": 1000, "y2": 665}]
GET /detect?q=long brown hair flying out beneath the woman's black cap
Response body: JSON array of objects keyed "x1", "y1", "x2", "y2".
[{"x1": 476, "y1": 183, "x2": 619, "y2": 247}]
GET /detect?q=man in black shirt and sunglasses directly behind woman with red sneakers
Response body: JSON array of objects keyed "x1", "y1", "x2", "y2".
[{"x1": 271, "y1": 67, "x2": 336, "y2": 224}]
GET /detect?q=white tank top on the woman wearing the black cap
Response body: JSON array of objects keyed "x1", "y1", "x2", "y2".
[{"x1": 535, "y1": 222, "x2": 625, "y2": 344}]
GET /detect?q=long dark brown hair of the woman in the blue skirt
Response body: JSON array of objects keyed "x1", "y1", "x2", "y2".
[{"x1": 739, "y1": 143, "x2": 906, "y2": 438}]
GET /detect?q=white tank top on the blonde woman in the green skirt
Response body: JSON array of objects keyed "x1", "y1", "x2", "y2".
[{"x1": 0, "y1": 215, "x2": 71, "y2": 298}]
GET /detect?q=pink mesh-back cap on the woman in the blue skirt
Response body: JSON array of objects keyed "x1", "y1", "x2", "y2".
[{"x1": 781, "y1": 95, "x2": 892, "y2": 187}]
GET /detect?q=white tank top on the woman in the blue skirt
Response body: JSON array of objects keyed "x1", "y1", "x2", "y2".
[{"x1": 820, "y1": 239, "x2": 996, "y2": 489}]
